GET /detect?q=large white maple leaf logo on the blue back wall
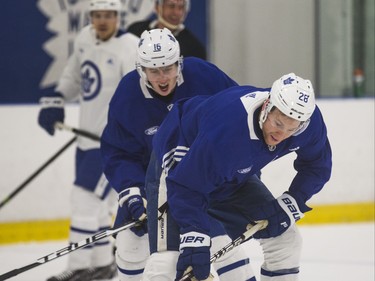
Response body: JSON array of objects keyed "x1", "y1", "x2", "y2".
[{"x1": 37, "y1": 0, "x2": 155, "y2": 89}]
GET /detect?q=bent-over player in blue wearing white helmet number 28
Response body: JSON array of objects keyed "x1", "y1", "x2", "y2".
[{"x1": 143, "y1": 73, "x2": 332, "y2": 281}]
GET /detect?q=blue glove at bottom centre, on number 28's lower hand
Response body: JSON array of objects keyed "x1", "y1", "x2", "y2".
[{"x1": 176, "y1": 231, "x2": 211, "y2": 280}]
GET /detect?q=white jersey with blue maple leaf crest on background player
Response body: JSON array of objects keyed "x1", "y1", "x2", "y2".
[{"x1": 56, "y1": 25, "x2": 139, "y2": 150}]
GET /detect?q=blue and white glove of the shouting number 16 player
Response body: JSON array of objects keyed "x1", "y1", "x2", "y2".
[{"x1": 114, "y1": 187, "x2": 147, "y2": 236}]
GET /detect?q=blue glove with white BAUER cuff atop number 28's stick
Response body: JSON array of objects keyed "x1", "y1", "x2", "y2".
[{"x1": 250, "y1": 192, "x2": 311, "y2": 238}]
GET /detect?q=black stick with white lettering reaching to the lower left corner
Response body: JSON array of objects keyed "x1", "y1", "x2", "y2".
[{"x1": 0, "y1": 220, "x2": 145, "y2": 281}]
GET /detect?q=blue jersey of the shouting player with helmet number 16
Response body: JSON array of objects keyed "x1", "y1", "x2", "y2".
[{"x1": 101, "y1": 57, "x2": 238, "y2": 193}]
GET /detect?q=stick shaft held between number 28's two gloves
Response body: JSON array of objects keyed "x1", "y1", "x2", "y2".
[{"x1": 179, "y1": 220, "x2": 268, "y2": 281}]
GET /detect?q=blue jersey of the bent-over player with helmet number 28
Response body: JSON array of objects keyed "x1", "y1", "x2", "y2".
[{"x1": 153, "y1": 86, "x2": 332, "y2": 231}]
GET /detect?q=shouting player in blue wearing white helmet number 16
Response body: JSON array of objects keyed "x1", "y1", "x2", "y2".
[{"x1": 101, "y1": 28, "x2": 254, "y2": 281}]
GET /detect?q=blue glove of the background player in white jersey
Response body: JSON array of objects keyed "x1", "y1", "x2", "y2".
[{"x1": 38, "y1": 93, "x2": 65, "y2": 136}]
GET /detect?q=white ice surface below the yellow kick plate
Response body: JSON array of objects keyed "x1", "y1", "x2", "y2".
[{"x1": 0, "y1": 223, "x2": 375, "y2": 281}]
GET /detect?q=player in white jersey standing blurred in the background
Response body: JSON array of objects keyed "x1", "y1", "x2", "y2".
[{"x1": 38, "y1": 0, "x2": 138, "y2": 281}]
